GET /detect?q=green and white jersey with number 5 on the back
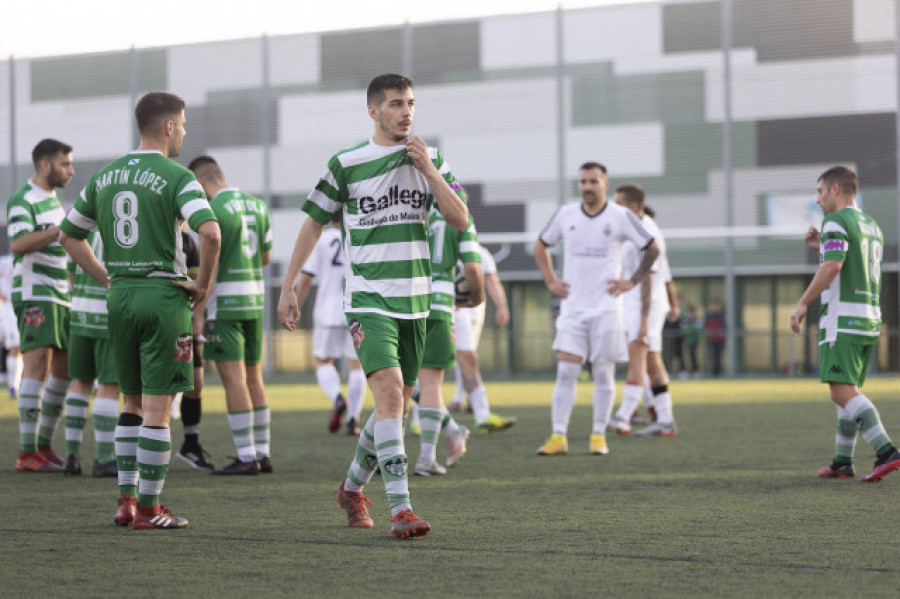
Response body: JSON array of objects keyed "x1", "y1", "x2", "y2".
[{"x1": 206, "y1": 187, "x2": 272, "y2": 320}]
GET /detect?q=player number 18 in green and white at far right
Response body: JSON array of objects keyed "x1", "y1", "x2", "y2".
[{"x1": 791, "y1": 166, "x2": 900, "y2": 482}]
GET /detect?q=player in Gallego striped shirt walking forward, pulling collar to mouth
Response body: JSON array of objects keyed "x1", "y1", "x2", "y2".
[{"x1": 278, "y1": 74, "x2": 468, "y2": 539}]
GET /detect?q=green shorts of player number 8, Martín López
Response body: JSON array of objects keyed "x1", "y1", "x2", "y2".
[{"x1": 107, "y1": 279, "x2": 194, "y2": 395}]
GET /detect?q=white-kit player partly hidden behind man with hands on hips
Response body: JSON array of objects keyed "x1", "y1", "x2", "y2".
[{"x1": 610, "y1": 184, "x2": 677, "y2": 437}]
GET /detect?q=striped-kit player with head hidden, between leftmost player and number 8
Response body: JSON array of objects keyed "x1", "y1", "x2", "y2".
[{"x1": 63, "y1": 231, "x2": 119, "y2": 476}]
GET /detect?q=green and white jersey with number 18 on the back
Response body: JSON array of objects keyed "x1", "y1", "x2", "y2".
[{"x1": 819, "y1": 207, "x2": 884, "y2": 345}]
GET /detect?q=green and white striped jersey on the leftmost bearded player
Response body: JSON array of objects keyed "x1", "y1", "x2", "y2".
[{"x1": 6, "y1": 179, "x2": 70, "y2": 306}]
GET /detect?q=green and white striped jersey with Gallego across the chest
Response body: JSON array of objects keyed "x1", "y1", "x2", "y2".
[{"x1": 302, "y1": 139, "x2": 465, "y2": 319}]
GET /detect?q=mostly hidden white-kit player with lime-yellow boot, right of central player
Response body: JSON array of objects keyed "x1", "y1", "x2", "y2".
[{"x1": 450, "y1": 244, "x2": 516, "y2": 433}]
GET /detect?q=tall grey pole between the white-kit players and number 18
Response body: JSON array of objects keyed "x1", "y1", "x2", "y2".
[{"x1": 722, "y1": 0, "x2": 736, "y2": 377}]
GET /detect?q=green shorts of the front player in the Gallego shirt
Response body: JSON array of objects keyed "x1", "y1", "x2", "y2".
[{"x1": 347, "y1": 312, "x2": 425, "y2": 387}]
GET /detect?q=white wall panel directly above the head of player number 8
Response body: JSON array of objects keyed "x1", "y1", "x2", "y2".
[{"x1": 167, "y1": 38, "x2": 262, "y2": 105}]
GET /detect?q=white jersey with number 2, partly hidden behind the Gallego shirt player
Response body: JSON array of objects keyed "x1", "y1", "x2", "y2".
[{"x1": 302, "y1": 226, "x2": 347, "y2": 327}]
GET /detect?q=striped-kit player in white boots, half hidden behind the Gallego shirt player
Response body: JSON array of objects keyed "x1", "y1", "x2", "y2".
[{"x1": 414, "y1": 210, "x2": 484, "y2": 476}]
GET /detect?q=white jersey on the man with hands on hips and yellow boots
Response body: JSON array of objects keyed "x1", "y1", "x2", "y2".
[{"x1": 539, "y1": 202, "x2": 653, "y2": 317}]
